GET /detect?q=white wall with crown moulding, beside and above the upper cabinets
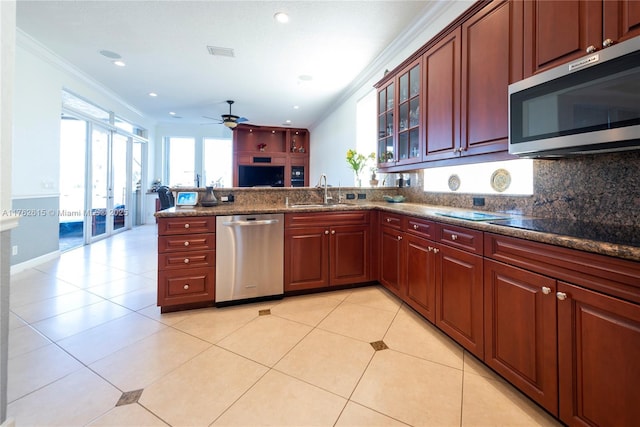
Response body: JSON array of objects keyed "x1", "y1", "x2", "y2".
[{"x1": 309, "y1": 1, "x2": 474, "y2": 186}]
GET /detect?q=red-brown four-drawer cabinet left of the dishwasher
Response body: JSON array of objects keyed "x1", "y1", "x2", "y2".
[{"x1": 157, "y1": 216, "x2": 216, "y2": 313}]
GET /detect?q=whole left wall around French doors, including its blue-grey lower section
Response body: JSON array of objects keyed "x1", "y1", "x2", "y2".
[{"x1": 11, "y1": 30, "x2": 155, "y2": 265}]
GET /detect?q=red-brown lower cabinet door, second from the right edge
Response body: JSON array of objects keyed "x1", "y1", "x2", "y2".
[{"x1": 484, "y1": 259, "x2": 558, "y2": 416}]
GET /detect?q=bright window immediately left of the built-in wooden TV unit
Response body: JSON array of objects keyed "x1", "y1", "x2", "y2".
[{"x1": 201, "y1": 138, "x2": 233, "y2": 187}]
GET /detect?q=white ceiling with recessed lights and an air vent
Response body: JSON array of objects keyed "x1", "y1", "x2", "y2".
[{"x1": 17, "y1": 0, "x2": 452, "y2": 127}]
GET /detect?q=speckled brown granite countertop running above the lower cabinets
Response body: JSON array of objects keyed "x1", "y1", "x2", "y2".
[{"x1": 155, "y1": 202, "x2": 640, "y2": 262}]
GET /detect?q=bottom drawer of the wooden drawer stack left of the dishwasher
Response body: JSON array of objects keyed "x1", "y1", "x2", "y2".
[{"x1": 158, "y1": 268, "x2": 215, "y2": 306}]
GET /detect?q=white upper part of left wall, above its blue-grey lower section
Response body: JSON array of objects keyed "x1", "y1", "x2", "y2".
[{"x1": 12, "y1": 31, "x2": 154, "y2": 198}]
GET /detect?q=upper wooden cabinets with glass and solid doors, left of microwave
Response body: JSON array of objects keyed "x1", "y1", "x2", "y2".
[{"x1": 376, "y1": 0, "x2": 524, "y2": 172}]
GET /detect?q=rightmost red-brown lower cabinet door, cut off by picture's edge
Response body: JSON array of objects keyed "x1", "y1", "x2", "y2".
[{"x1": 557, "y1": 282, "x2": 640, "y2": 426}]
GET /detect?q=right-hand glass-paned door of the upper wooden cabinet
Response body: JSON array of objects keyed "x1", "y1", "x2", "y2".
[{"x1": 396, "y1": 61, "x2": 422, "y2": 163}]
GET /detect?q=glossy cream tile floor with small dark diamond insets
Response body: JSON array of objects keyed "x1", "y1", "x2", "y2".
[{"x1": 8, "y1": 226, "x2": 557, "y2": 427}]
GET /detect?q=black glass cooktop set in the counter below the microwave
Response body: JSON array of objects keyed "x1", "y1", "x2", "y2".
[{"x1": 489, "y1": 218, "x2": 640, "y2": 247}]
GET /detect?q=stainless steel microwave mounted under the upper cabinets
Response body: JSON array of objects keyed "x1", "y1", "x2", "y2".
[{"x1": 509, "y1": 37, "x2": 640, "y2": 157}]
